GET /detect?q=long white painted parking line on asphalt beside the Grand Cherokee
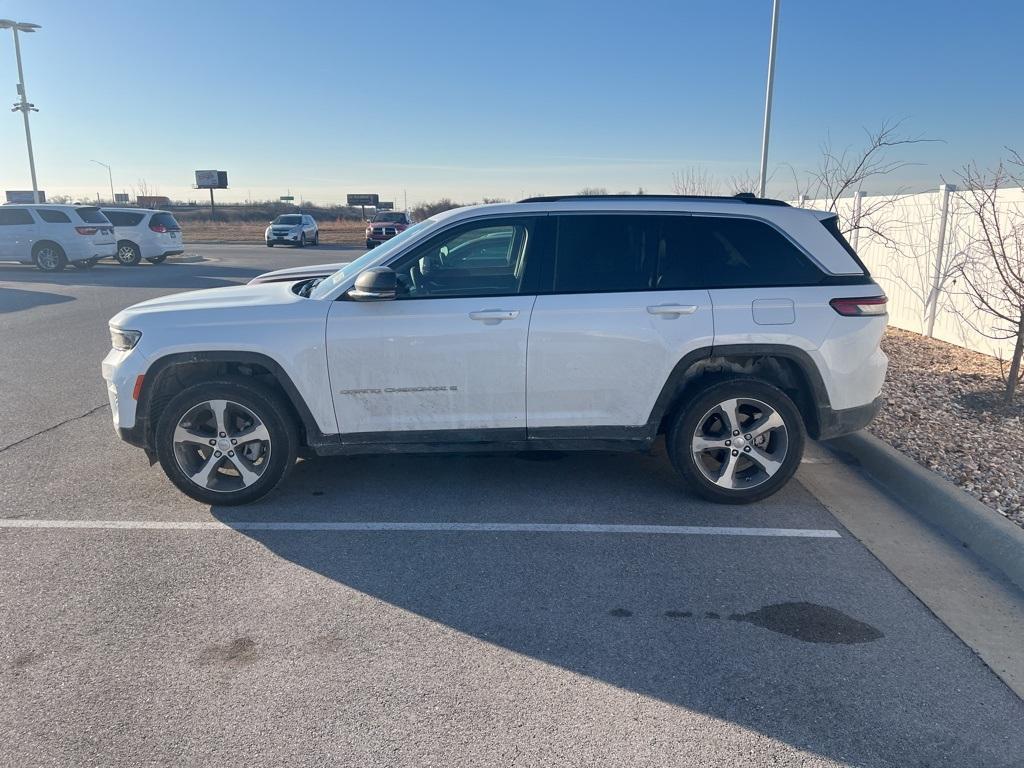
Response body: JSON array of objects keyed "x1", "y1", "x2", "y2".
[{"x1": 0, "y1": 519, "x2": 841, "y2": 539}]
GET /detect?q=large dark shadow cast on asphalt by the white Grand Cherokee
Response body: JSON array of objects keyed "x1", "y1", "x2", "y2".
[{"x1": 212, "y1": 454, "x2": 1018, "y2": 766}]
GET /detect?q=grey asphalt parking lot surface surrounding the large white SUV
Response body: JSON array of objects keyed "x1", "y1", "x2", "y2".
[{"x1": 0, "y1": 245, "x2": 1024, "y2": 766}]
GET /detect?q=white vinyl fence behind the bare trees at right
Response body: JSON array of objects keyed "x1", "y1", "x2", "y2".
[{"x1": 802, "y1": 186, "x2": 1024, "y2": 359}]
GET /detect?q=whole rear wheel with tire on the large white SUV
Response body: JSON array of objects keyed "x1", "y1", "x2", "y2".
[{"x1": 667, "y1": 378, "x2": 805, "y2": 504}]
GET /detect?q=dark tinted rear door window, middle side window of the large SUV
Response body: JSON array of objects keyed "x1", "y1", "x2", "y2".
[{"x1": 555, "y1": 215, "x2": 658, "y2": 293}]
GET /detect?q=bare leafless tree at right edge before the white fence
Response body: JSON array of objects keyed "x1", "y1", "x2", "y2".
[{"x1": 959, "y1": 156, "x2": 1024, "y2": 404}]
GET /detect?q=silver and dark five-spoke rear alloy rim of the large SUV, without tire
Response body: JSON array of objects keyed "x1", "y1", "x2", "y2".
[{"x1": 690, "y1": 397, "x2": 790, "y2": 490}]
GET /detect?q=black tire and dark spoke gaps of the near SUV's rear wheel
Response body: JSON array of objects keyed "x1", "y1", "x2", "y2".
[{"x1": 666, "y1": 377, "x2": 806, "y2": 504}]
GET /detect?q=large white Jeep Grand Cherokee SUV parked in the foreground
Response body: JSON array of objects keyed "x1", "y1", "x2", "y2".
[{"x1": 102, "y1": 196, "x2": 887, "y2": 505}]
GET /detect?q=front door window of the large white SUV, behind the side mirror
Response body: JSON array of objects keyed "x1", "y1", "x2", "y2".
[{"x1": 390, "y1": 219, "x2": 530, "y2": 299}]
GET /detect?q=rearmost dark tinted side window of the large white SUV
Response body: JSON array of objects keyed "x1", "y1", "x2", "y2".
[{"x1": 689, "y1": 216, "x2": 823, "y2": 288}]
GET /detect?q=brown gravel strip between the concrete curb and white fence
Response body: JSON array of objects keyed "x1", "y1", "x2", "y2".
[{"x1": 868, "y1": 328, "x2": 1024, "y2": 527}]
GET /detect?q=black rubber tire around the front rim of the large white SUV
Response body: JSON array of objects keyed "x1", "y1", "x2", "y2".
[{"x1": 156, "y1": 377, "x2": 299, "y2": 506}]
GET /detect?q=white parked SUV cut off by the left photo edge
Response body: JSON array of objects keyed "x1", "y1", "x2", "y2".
[{"x1": 0, "y1": 203, "x2": 116, "y2": 272}]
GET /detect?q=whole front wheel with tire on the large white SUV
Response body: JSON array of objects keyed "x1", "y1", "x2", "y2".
[{"x1": 156, "y1": 377, "x2": 298, "y2": 505}]
